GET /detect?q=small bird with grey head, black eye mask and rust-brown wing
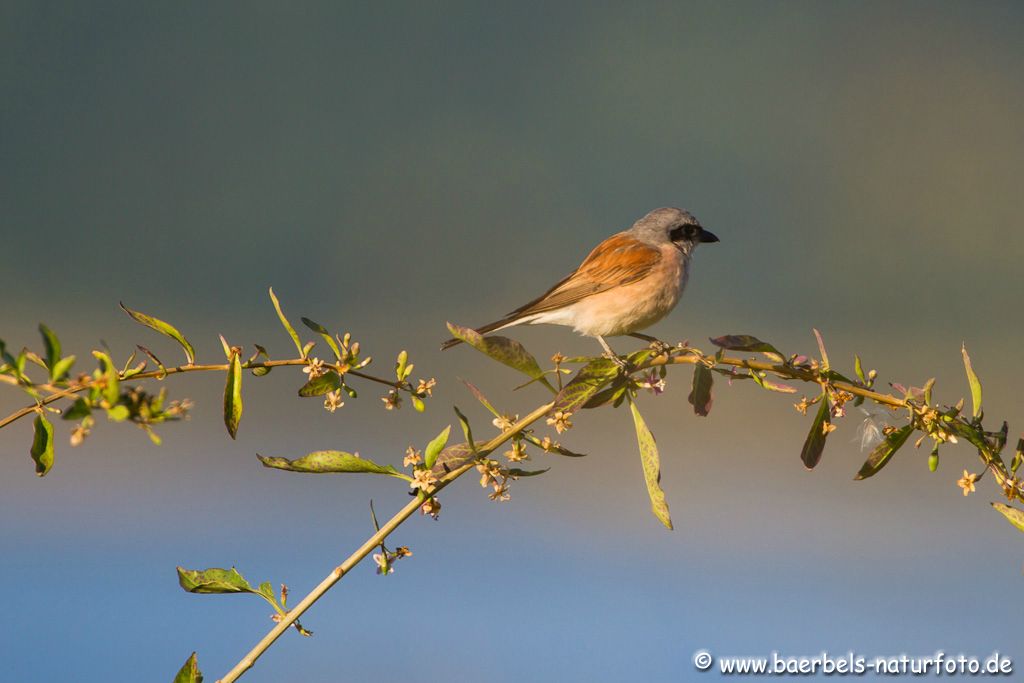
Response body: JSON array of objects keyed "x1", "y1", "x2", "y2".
[{"x1": 441, "y1": 208, "x2": 718, "y2": 360}]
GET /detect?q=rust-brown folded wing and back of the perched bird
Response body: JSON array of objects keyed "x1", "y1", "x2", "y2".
[{"x1": 506, "y1": 232, "x2": 662, "y2": 319}]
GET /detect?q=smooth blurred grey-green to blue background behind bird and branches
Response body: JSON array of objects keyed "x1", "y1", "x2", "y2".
[{"x1": 0, "y1": 2, "x2": 1024, "y2": 682}]
